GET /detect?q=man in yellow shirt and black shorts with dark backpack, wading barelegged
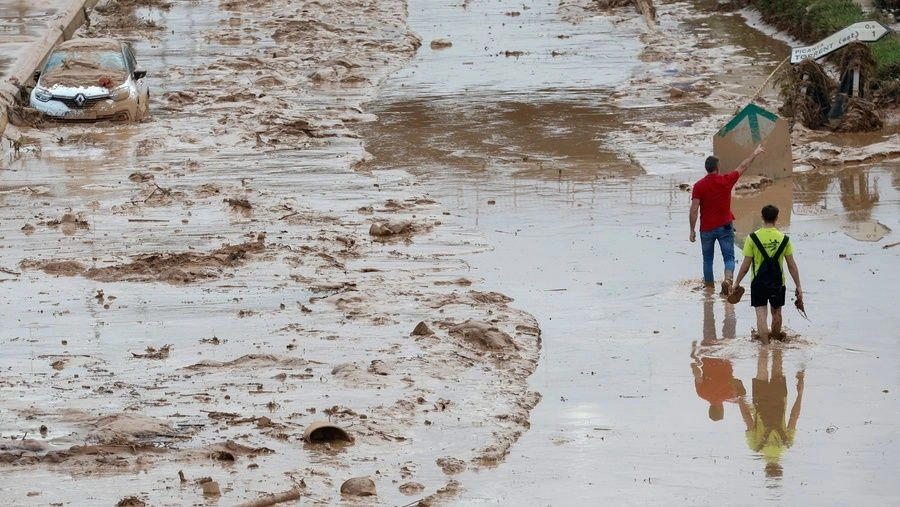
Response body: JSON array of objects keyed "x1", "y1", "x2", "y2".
[{"x1": 732, "y1": 204, "x2": 803, "y2": 344}]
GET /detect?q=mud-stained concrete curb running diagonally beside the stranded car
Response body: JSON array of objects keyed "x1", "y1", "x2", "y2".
[{"x1": 0, "y1": 0, "x2": 100, "y2": 142}]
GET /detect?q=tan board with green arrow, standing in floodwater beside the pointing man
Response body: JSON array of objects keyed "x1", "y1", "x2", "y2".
[{"x1": 713, "y1": 104, "x2": 793, "y2": 180}]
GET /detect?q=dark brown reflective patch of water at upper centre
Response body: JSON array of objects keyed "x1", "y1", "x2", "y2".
[{"x1": 365, "y1": 92, "x2": 648, "y2": 181}]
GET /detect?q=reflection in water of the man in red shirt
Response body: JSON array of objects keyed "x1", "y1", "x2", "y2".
[{"x1": 691, "y1": 289, "x2": 745, "y2": 421}]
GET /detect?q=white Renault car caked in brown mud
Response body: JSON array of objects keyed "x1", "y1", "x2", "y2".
[{"x1": 29, "y1": 38, "x2": 150, "y2": 121}]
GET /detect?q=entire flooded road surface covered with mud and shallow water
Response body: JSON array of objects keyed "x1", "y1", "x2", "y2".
[{"x1": 0, "y1": 0, "x2": 900, "y2": 505}]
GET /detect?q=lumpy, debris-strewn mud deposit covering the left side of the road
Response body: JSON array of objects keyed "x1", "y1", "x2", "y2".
[{"x1": 0, "y1": 0, "x2": 540, "y2": 505}]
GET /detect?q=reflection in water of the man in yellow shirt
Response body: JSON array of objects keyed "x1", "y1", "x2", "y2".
[{"x1": 739, "y1": 347, "x2": 805, "y2": 477}]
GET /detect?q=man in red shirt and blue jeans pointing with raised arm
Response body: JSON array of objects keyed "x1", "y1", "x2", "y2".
[{"x1": 690, "y1": 145, "x2": 766, "y2": 294}]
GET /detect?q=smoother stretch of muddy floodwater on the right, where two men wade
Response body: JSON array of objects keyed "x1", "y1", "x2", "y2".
[{"x1": 364, "y1": 2, "x2": 900, "y2": 505}]
